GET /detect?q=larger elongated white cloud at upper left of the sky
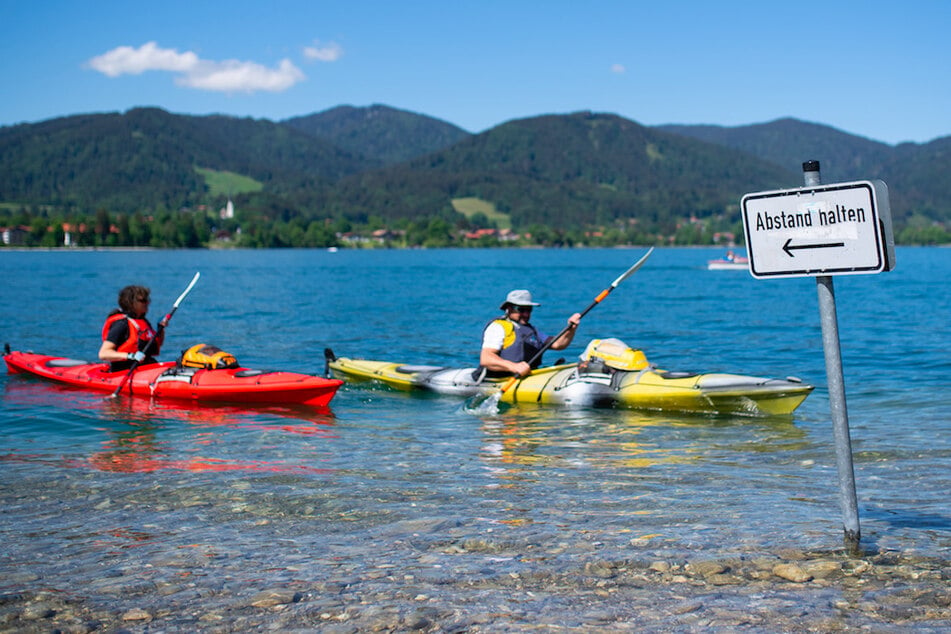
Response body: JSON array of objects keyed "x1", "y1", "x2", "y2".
[{"x1": 89, "y1": 42, "x2": 305, "y2": 93}]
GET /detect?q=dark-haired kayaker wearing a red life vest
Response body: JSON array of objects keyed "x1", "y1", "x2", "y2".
[{"x1": 99, "y1": 286, "x2": 165, "y2": 372}]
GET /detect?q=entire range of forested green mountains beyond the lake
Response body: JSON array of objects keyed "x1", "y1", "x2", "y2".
[{"x1": 0, "y1": 105, "x2": 951, "y2": 244}]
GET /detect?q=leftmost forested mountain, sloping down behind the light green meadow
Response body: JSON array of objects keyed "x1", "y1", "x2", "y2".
[{"x1": 0, "y1": 108, "x2": 379, "y2": 212}]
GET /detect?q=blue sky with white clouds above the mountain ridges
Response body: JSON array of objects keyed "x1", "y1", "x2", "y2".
[{"x1": 0, "y1": 0, "x2": 951, "y2": 144}]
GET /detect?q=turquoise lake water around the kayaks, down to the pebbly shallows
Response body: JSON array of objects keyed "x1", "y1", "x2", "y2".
[{"x1": 0, "y1": 248, "x2": 951, "y2": 624}]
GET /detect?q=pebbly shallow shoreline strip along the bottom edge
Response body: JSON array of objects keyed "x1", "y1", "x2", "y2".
[{"x1": 0, "y1": 539, "x2": 951, "y2": 633}]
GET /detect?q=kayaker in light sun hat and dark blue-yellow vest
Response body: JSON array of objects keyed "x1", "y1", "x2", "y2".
[{"x1": 479, "y1": 290, "x2": 581, "y2": 377}]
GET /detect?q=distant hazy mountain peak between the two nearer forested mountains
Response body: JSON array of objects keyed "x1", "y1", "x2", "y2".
[{"x1": 281, "y1": 104, "x2": 469, "y2": 164}]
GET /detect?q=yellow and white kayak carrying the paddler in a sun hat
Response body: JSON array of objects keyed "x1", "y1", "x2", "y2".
[{"x1": 325, "y1": 340, "x2": 814, "y2": 416}]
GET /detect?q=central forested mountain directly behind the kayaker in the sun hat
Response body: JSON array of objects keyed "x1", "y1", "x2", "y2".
[{"x1": 318, "y1": 112, "x2": 796, "y2": 228}]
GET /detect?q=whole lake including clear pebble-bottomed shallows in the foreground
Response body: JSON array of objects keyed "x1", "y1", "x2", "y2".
[{"x1": 0, "y1": 248, "x2": 951, "y2": 632}]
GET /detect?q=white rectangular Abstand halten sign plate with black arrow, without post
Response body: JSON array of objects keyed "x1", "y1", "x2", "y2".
[{"x1": 741, "y1": 180, "x2": 895, "y2": 278}]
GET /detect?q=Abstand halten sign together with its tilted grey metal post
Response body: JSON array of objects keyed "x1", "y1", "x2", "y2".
[{"x1": 741, "y1": 161, "x2": 895, "y2": 554}]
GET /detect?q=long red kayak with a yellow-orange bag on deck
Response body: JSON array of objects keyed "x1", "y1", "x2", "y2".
[{"x1": 3, "y1": 350, "x2": 343, "y2": 407}]
